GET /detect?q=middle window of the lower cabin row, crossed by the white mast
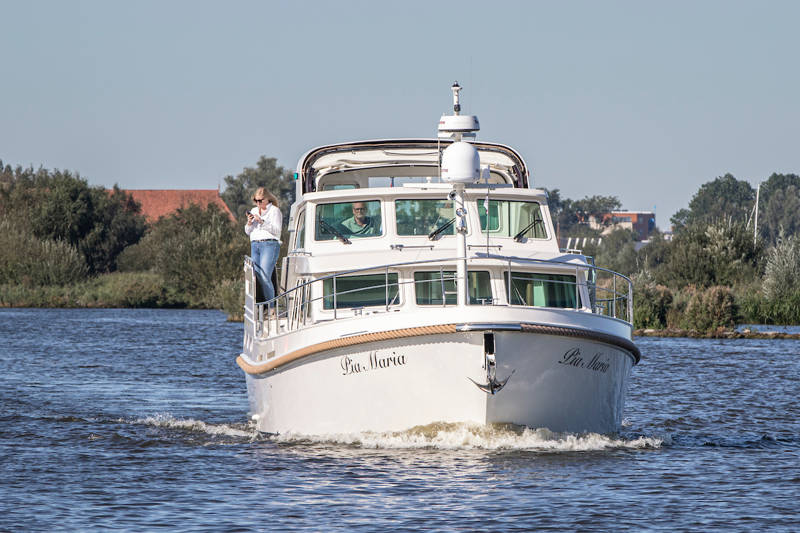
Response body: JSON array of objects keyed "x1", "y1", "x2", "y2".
[{"x1": 414, "y1": 270, "x2": 493, "y2": 305}]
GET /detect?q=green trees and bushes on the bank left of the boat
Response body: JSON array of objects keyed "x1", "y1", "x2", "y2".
[{"x1": 0, "y1": 157, "x2": 294, "y2": 317}]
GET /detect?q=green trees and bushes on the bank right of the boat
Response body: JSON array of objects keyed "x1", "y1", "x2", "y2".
[{"x1": 556, "y1": 173, "x2": 800, "y2": 331}]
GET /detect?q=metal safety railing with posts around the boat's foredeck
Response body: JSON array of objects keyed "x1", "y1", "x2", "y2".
[{"x1": 245, "y1": 254, "x2": 633, "y2": 335}]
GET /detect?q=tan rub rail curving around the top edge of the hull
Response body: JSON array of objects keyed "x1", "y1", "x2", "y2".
[{"x1": 236, "y1": 323, "x2": 641, "y2": 375}]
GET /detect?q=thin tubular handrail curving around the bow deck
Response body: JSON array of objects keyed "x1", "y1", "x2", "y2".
[{"x1": 245, "y1": 253, "x2": 633, "y2": 335}]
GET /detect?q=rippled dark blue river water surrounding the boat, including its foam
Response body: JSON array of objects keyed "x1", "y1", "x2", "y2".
[{"x1": 0, "y1": 309, "x2": 800, "y2": 531}]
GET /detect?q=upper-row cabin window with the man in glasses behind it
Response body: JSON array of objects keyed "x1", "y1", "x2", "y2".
[{"x1": 315, "y1": 200, "x2": 383, "y2": 241}]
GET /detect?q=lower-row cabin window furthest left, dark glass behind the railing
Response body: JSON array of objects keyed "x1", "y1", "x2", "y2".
[{"x1": 322, "y1": 273, "x2": 399, "y2": 309}]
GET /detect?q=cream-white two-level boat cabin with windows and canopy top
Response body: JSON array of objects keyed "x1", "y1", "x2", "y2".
[{"x1": 258, "y1": 140, "x2": 608, "y2": 326}]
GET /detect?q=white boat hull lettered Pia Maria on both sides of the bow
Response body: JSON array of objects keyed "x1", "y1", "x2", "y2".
[{"x1": 243, "y1": 331, "x2": 634, "y2": 435}]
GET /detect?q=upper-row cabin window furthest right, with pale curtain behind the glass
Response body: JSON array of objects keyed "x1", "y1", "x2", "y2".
[{"x1": 477, "y1": 200, "x2": 547, "y2": 239}]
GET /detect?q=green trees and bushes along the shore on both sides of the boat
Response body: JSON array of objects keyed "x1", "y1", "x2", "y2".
[{"x1": 0, "y1": 156, "x2": 800, "y2": 332}]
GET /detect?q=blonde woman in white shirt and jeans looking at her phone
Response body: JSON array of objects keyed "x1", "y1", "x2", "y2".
[{"x1": 244, "y1": 187, "x2": 283, "y2": 301}]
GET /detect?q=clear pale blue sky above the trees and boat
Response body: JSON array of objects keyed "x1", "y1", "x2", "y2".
[{"x1": 0, "y1": 0, "x2": 800, "y2": 229}]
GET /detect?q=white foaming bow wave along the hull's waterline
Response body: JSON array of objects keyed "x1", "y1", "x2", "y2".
[{"x1": 271, "y1": 423, "x2": 663, "y2": 452}]
